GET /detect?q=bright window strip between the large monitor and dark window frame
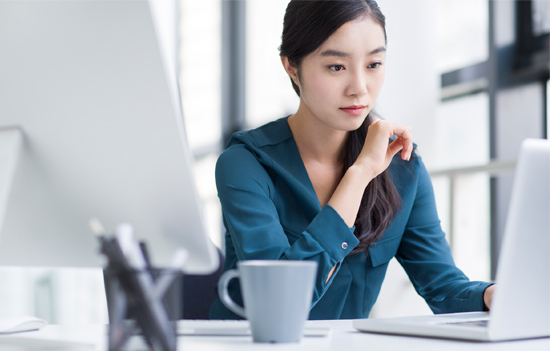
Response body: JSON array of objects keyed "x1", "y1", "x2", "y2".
[{"x1": 178, "y1": 0, "x2": 223, "y2": 247}]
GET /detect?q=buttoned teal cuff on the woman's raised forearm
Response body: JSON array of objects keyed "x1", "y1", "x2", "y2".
[{"x1": 306, "y1": 204, "x2": 359, "y2": 262}]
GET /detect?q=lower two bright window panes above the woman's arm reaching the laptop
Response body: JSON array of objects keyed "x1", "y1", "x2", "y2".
[{"x1": 433, "y1": 93, "x2": 490, "y2": 280}]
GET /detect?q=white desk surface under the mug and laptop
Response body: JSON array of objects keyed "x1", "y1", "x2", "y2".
[{"x1": 0, "y1": 320, "x2": 550, "y2": 351}]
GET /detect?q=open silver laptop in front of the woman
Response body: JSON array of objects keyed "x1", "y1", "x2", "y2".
[{"x1": 353, "y1": 139, "x2": 550, "y2": 341}]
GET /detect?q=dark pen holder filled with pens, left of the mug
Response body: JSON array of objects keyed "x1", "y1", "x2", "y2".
[{"x1": 103, "y1": 267, "x2": 183, "y2": 351}]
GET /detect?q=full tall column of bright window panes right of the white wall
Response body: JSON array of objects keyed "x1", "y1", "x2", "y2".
[{"x1": 431, "y1": 0, "x2": 490, "y2": 280}]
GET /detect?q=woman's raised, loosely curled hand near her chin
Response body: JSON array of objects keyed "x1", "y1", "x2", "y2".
[{"x1": 355, "y1": 119, "x2": 413, "y2": 178}]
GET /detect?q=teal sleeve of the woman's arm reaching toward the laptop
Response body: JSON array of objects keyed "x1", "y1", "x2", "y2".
[{"x1": 396, "y1": 158, "x2": 491, "y2": 313}]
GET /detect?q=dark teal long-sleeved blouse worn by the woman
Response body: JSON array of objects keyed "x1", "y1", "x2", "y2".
[{"x1": 210, "y1": 118, "x2": 490, "y2": 319}]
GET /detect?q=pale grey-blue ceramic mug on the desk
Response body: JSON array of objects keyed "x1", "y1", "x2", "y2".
[{"x1": 218, "y1": 260, "x2": 317, "y2": 342}]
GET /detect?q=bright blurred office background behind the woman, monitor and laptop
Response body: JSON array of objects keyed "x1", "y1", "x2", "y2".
[{"x1": 0, "y1": 0, "x2": 550, "y2": 323}]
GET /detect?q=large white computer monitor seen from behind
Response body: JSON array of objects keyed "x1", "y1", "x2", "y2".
[{"x1": 0, "y1": 0, "x2": 218, "y2": 273}]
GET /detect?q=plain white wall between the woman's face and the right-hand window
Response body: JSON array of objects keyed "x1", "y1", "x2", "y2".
[{"x1": 375, "y1": 0, "x2": 439, "y2": 165}]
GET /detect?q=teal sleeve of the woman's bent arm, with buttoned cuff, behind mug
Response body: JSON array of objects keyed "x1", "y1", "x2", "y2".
[{"x1": 216, "y1": 145, "x2": 359, "y2": 306}]
